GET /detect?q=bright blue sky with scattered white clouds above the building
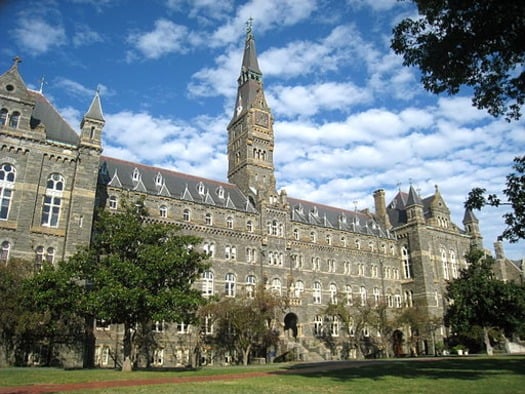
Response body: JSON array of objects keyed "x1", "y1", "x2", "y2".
[{"x1": 0, "y1": 0, "x2": 525, "y2": 259}]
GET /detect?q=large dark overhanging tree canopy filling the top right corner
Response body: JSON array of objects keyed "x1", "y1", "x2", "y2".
[{"x1": 391, "y1": 0, "x2": 525, "y2": 120}]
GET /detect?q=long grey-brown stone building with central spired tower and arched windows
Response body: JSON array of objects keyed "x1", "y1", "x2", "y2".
[{"x1": 0, "y1": 28, "x2": 520, "y2": 366}]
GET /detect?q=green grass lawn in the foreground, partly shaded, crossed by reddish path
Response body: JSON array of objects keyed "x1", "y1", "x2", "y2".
[{"x1": 0, "y1": 356, "x2": 525, "y2": 394}]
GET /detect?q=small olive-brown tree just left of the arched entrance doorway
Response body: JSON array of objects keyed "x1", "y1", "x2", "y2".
[{"x1": 204, "y1": 286, "x2": 283, "y2": 365}]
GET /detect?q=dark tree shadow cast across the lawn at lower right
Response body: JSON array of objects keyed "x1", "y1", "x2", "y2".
[{"x1": 274, "y1": 356, "x2": 525, "y2": 382}]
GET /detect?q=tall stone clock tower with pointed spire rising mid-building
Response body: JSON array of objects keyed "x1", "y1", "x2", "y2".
[{"x1": 228, "y1": 20, "x2": 277, "y2": 207}]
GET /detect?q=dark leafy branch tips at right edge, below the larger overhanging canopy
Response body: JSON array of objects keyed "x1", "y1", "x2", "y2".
[{"x1": 465, "y1": 156, "x2": 525, "y2": 242}]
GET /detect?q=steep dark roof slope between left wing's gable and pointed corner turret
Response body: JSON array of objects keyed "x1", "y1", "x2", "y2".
[{"x1": 28, "y1": 90, "x2": 80, "y2": 146}]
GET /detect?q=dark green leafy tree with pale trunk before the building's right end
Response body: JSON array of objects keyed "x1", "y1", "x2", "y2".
[{"x1": 445, "y1": 249, "x2": 525, "y2": 355}]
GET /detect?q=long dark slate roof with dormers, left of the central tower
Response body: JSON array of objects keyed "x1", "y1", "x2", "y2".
[{"x1": 99, "y1": 156, "x2": 256, "y2": 212}]
